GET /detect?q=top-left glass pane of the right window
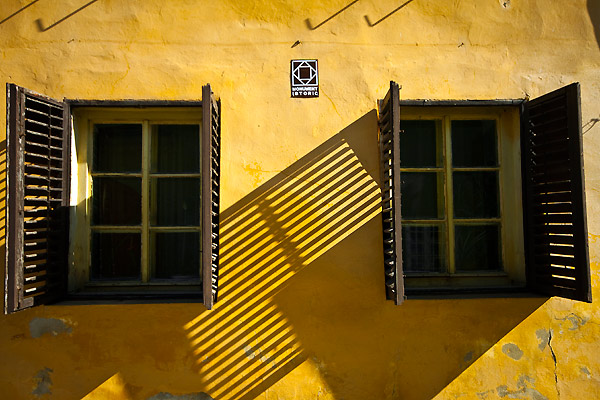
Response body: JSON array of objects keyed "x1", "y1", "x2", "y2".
[{"x1": 400, "y1": 120, "x2": 442, "y2": 168}]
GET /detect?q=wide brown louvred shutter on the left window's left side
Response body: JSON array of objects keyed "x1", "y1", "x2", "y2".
[{"x1": 5, "y1": 84, "x2": 70, "y2": 313}]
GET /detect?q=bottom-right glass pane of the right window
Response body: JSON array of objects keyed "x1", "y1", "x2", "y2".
[{"x1": 454, "y1": 224, "x2": 502, "y2": 271}]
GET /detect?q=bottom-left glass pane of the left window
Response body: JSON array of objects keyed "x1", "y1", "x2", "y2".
[{"x1": 91, "y1": 232, "x2": 141, "y2": 279}]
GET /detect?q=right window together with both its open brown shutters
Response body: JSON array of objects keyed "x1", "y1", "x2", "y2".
[{"x1": 380, "y1": 82, "x2": 591, "y2": 304}]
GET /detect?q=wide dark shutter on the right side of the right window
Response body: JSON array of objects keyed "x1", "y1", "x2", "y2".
[{"x1": 521, "y1": 83, "x2": 592, "y2": 302}]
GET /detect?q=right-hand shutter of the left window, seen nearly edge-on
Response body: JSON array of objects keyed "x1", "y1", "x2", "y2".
[{"x1": 202, "y1": 85, "x2": 221, "y2": 310}]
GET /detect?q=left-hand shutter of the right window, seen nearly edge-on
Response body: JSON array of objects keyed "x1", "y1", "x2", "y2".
[{"x1": 379, "y1": 82, "x2": 404, "y2": 304}]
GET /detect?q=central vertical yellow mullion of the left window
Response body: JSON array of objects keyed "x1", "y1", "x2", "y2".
[{"x1": 141, "y1": 120, "x2": 150, "y2": 283}]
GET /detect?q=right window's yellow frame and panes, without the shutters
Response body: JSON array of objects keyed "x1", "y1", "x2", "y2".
[{"x1": 399, "y1": 107, "x2": 525, "y2": 289}]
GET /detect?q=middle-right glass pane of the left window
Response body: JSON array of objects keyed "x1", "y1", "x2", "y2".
[{"x1": 150, "y1": 178, "x2": 200, "y2": 226}]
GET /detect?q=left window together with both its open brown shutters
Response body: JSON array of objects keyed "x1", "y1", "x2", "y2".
[{"x1": 5, "y1": 84, "x2": 220, "y2": 312}]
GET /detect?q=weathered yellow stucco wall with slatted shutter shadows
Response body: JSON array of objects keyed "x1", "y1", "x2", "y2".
[{"x1": 0, "y1": 0, "x2": 600, "y2": 400}]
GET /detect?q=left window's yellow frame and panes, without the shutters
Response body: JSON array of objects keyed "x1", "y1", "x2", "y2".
[{"x1": 69, "y1": 107, "x2": 201, "y2": 292}]
